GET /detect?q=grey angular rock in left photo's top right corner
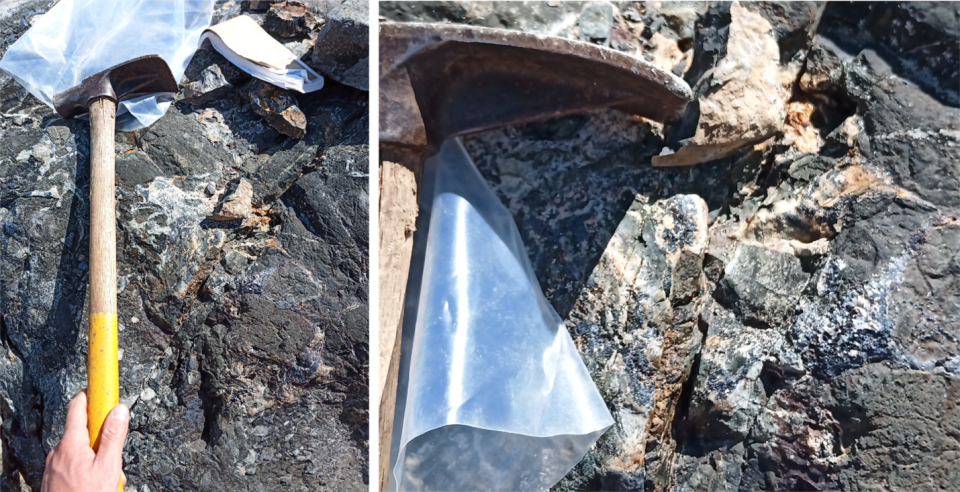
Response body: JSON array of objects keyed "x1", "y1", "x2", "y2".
[{"x1": 313, "y1": 0, "x2": 371, "y2": 91}]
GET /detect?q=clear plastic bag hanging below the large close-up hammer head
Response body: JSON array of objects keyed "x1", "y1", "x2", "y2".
[{"x1": 389, "y1": 140, "x2": 613, "y2": 492}]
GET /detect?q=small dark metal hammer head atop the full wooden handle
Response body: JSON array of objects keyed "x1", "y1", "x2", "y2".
[{"x1": 53, "y1": 55, "x2": 178, "y2": 118}]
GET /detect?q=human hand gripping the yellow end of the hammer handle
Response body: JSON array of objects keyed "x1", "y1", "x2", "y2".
[{"x1": 40, "y1": 391, "x2": 130, "y2": 492}]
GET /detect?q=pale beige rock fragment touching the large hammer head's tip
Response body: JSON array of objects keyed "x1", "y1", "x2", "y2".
[{"x1": 653, "y1": 1, "x2": 785, "y2": 166}]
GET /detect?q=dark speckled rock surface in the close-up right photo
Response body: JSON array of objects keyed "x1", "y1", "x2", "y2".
[{"x1": 377, "y1": 0, "x2": 960, "y2": 492}]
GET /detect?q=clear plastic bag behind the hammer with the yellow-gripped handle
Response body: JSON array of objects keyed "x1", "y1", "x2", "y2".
[{"x1": 0, "y1": 0, "x2": 214, "y2": 131}]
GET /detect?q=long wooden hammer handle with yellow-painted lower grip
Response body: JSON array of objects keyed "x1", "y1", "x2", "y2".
[{"x1": 87, "y1": 97, "x2": 122, "y2": 490}]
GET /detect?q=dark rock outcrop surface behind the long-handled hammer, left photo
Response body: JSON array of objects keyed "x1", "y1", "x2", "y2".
[{"x1": 0, "y1": 0, "x2": 371, "y2": 492}]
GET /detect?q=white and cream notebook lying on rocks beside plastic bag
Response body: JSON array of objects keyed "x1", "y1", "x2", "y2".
[{"x1": 200, "y1": 15, "x2": 323, "y2": 92}]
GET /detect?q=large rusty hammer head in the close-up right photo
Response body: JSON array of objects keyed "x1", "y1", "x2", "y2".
[{"x1": 377, "y1": 22, "x2": 692, "y2": 160}]
